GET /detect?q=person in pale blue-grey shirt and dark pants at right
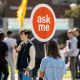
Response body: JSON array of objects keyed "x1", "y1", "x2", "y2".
[{"x1": 65, "y1": 30, "x2": 79, "y2": 80}]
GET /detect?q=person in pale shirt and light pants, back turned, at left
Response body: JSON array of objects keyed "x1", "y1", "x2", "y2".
[{"x1": 4, "y1": 31, "x2": 17, "y2": 80}]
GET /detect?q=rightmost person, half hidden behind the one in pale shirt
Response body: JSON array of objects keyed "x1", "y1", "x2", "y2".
[{"x1": 73, "y1": 28, "x2": 80, "y2": 79}]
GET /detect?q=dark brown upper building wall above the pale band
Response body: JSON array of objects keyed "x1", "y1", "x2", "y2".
[{"x1": 6, "y1": 0, "x2": 78, "y2": 18}]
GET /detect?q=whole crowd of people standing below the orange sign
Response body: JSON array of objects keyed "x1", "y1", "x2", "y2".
[{"x1": 0, "y1": 28, "x2": 80, "y2": 80}]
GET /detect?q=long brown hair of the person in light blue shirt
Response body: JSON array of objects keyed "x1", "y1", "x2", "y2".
[{"x1": 47, "y1": 40, "x2": 61, "y2": 58}]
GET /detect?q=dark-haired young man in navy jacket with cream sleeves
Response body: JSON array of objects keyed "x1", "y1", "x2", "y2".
[{"x1": 16, "y1": 30, "x2": 36, "y2": 80}]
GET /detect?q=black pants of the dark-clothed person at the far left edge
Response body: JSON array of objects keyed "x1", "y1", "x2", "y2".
[{"x1": 0, "y1": 61, "x2": 9, "y2": 80}]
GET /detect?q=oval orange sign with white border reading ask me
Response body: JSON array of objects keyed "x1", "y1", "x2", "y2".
[{"x1": 31, "y1": 4, "x2": 56, "y2": 42}]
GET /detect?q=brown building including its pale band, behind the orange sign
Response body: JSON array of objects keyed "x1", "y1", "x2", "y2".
[{"x1": 1, "y1": 0, "x2": 78, "y2": 33}]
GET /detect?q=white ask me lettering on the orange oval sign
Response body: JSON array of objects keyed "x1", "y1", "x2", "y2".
[{"x1": 37, "y1": 15, "x2": 50, "y2": 31}]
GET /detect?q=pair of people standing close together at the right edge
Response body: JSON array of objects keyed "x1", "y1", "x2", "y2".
[{"x1": 64, "y1": 28, "x2": 80, "y2": 80}]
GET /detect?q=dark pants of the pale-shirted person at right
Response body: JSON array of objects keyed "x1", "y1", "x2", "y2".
[{"x1": 70, "y1": 57, "x2": 76, "y2": 80}]
